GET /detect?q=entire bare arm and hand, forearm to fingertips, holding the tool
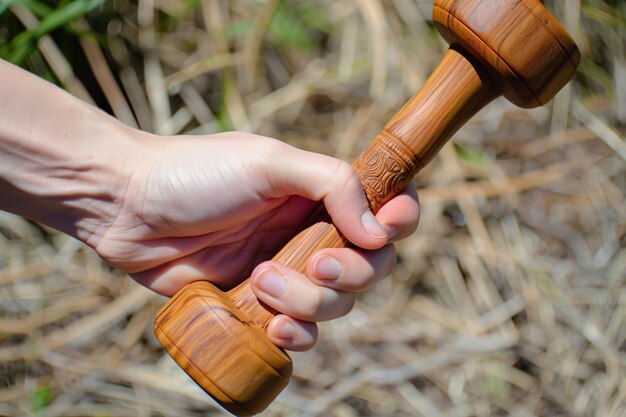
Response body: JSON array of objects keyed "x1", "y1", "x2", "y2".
[{"x1": 0, "y1": 60, "x2": 419, "y2": 350}]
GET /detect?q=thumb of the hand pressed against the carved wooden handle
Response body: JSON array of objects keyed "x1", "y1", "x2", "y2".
[{"x1": 254, "y1": 143, "x2": 388, "y2": 250}]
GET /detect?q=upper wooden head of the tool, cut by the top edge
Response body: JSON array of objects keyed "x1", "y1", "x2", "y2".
[{"x1": 433, "y1": 0, "x2": 580, "y2": 108}]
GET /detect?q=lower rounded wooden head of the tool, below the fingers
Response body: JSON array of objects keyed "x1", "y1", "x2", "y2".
[{"x1": 154, "y1": 281, "x2": 292, "y2": 416}]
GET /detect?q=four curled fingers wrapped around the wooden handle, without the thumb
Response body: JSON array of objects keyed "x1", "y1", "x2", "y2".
[{"x1": 251, "y1": 179, "x2": 420, "y2": 350}]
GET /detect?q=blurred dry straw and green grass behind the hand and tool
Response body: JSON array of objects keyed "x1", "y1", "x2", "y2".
[{"x1": 0, "y1": 0, "x2": 626, "y2": 417}]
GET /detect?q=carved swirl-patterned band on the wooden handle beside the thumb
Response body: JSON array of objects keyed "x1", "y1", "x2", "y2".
[{"x1": 354, "y1": 130, "x2": 424, "y2": 213}]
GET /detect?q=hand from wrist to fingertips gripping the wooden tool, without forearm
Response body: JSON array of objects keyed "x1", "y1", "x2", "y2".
[{"x1": 94, "y1": 132, "x2": 419, "y2": 350}]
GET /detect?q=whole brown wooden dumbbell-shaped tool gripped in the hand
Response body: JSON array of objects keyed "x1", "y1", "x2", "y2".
[{"x1": 154, "y1": 0, "x2": 580, "y2": 416}]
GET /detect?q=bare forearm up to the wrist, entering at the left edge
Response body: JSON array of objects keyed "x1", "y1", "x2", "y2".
[{"x1": 0, "y1": 60, "x2": 145, "y2": 245}]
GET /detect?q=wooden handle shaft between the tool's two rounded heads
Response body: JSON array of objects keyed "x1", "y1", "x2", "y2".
[{"x1": 228, "y1": 48, "x2": 499, "y2": 329}]
